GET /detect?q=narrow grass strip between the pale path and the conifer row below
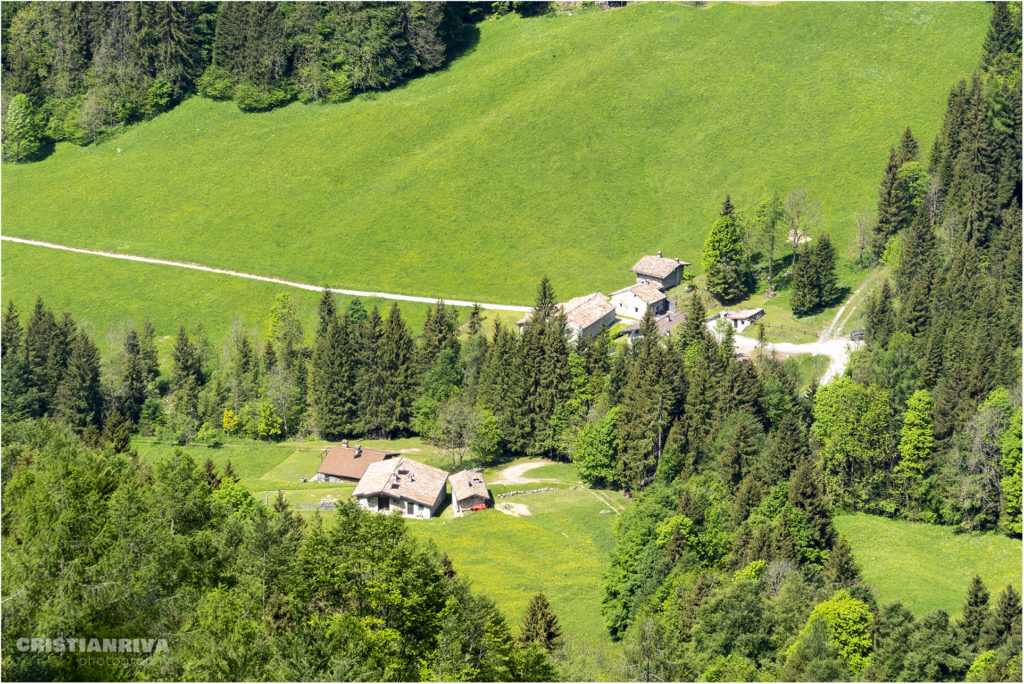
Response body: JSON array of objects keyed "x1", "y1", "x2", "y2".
[{"x1": 2, "y1": 240, "x2": 522, "y2": 356}]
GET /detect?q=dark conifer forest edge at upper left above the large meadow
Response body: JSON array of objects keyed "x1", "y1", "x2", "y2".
[{"x1": 2, "y1": 1, "x2": 549, "y2": 161}]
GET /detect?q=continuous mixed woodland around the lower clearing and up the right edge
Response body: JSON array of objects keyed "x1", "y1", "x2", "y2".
[{"x1": 0, "y1": 3, "x2": 1022, "y2": 681}]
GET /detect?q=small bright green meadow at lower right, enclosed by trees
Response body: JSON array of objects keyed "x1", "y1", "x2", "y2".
[{"x1": 835, "y1": 513, "x2": 1021, "y2": 615}]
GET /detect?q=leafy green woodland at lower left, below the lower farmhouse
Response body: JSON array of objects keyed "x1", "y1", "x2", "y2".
[{"x1": 2, "y1": 421, "x2": 563, "y2": 681}]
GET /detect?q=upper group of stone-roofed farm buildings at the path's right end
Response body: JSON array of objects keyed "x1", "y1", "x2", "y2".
[{"x1": 516, "y1": 252, "x2": 765, "y2": 344}]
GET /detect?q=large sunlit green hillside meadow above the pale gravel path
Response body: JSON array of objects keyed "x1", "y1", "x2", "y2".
[{"x1": 2, "y1": 3, "x2": 990, "y2": 305}]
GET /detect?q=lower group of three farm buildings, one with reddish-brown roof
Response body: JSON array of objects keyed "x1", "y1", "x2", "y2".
[{"x1": 313, "y1": 440, "x2": 490, "y2": 518}]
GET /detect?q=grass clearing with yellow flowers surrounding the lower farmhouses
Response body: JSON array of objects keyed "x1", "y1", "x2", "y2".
[{"x1": 133, "y1": 437, "x2": 626, "y2": 653}]
